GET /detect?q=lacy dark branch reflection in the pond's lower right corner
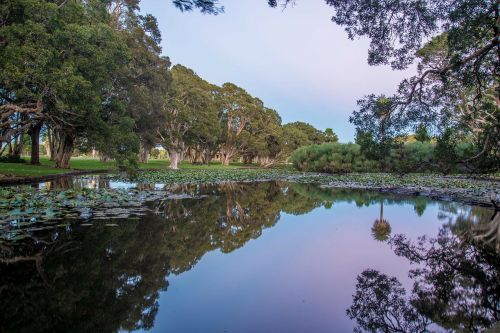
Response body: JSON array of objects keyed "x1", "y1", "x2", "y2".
[{"x1": 347, "y1": 213, "x2": 500, "y2": 332}]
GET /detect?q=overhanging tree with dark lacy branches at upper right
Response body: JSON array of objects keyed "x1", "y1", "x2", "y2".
[{"x1": 268, "y1": 0, "x2": 500, "y2": 171}]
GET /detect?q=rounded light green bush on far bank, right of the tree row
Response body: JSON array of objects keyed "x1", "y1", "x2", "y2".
[{"x1": 291, "y1": 143, "x2": 378, "y2": 173}]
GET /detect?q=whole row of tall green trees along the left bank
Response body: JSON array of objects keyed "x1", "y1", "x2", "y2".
[{"x1": 0, "y1": 0, "x2": 335, "y2": 170}]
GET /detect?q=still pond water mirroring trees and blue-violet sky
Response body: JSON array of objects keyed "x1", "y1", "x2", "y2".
[{"x1": 0, "y1": 176, "x2": 500, "y2": 332}]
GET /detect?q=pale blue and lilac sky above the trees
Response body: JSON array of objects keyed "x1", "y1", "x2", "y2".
[{"x1": 141, "y1": 0, "x2": 414, "y2": 142}]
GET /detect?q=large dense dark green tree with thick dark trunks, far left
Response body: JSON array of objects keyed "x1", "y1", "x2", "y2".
[{"x1": 0, "y1": 0, "x2": 137, "y2": 168}]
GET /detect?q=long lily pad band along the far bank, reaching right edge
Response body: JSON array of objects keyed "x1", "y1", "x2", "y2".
[{"x1": 114, "y1": 169, "x2": 500, "y2": 205}]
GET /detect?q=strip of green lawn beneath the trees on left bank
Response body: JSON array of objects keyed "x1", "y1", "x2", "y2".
[{"x1": 0, "y1": 156, "x2": 249, "y2": 177}]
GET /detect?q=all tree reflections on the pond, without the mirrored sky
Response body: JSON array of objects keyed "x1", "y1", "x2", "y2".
[{"x1": 0, "y1": 178, "x2": 500, "y2": 332}]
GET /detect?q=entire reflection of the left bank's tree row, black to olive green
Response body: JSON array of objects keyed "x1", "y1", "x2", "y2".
[{"x1": 0, "y1": 183, "x2": 285, "y2": 332}]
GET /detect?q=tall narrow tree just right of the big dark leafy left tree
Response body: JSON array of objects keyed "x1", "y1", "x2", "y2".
[{"x1": 103, "y1": 0, "x2": 172, "y2": 163}]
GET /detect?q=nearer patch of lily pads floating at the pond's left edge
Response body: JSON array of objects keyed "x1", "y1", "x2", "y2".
[{"x1": 0, "y1": 186, "x2": 166, "y2": 240}]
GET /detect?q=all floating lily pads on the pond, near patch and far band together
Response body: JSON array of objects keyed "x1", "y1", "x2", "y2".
[{"x1": 0, "y1": 169, "x2": 500, "y2": 240}]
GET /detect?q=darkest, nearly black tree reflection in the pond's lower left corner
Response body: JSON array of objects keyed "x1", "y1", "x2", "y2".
[{"x1": 0, "y1": 221, "x2": 168, "y2": 332}]
